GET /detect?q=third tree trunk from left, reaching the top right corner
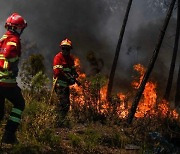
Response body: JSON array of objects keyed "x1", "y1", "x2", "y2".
[{"x1": 164, "y1": 0, "x2": 180, "y2": 101}]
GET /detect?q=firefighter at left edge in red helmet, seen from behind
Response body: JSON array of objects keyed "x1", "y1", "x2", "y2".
[{"x1": 0, "y1": 13, "x2": 27, "y2": 144}]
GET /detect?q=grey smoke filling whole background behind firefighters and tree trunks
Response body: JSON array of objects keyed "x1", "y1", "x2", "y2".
[{"x1": 0, "y1": 0, "x2": 178, "y2": 92}]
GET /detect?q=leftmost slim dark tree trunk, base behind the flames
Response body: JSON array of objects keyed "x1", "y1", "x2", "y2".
[{"x1": 106, "y1": 0, "x2": 132, "y2": 100}]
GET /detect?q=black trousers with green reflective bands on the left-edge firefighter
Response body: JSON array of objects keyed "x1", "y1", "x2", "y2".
[{"x1": 0, "y1": 86, "x2": 25, "y2": 133}]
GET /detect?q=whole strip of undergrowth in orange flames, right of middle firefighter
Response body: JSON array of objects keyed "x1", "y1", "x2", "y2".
[{"x1": 71, "y1": 58, "x2": 179, "y2": 120}]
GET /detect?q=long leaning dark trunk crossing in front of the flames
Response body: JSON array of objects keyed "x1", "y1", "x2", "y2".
[{"x1": 128, "y1": 0, "x2": 176, "y2": 124}]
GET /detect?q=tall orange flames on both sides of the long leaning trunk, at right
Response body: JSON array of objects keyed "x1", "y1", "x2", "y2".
[{"x1": 132, "y1": 64, "x2": 178, "y2": 119}]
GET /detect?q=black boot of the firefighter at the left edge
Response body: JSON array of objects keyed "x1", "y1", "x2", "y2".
[{"x1": 1, "y1": 131, "x2": 18, "y2": 144}]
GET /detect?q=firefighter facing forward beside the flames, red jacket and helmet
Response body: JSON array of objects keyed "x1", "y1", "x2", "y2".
[{"x1": 53, "y1": 39, "x2": 78, "y2": 121}]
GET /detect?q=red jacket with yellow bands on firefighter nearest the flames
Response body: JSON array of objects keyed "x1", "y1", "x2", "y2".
[{"x1": 53, "y1": 52, "x2": 76, "y2": 87}]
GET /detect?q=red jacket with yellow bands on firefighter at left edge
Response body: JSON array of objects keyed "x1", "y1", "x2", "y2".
[{"x1": 0, "y1": 31, "x2": 21, "y2": 86}]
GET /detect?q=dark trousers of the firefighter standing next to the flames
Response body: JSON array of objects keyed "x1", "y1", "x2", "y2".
[{"x1": 55, "y1": 86, "x2": 70, "y2": 119}]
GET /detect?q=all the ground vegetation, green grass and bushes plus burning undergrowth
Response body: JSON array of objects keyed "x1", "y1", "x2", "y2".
[{"x1": 0, "y1": 55, "x2": 180, "y2": 153}]
